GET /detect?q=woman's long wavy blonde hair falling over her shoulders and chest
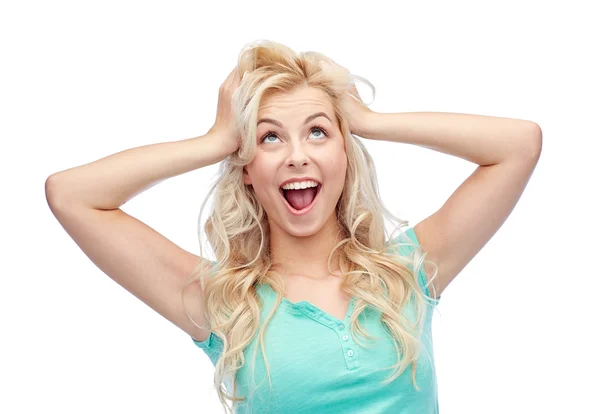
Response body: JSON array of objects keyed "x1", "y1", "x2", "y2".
[{"x1": 182, "y1": 41, "x2": 437, "y2": 410}]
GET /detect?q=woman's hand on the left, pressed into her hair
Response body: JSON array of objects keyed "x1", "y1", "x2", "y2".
[{"x1": 208, "y1": 66, "x2": 241, "y2": 153}]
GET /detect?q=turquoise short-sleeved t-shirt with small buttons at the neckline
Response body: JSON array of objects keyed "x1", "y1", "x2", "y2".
[{"x1": 192, "y1": 228, "x2": 441, "y2": 414}]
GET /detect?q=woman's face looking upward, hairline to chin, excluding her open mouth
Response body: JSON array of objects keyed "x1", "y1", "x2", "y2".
[{"x1": 244, "y1": 87, "x2": 347, "y2": 237}]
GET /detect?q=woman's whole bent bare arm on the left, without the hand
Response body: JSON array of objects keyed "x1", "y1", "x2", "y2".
[{"x1": 46, "y1": 130, "x2": 234, "y2": 341}]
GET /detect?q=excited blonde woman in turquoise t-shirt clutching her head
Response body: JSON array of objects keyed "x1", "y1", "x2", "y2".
[{"x1": 46, "y1": 41, "x2": 542, "y2": 414}]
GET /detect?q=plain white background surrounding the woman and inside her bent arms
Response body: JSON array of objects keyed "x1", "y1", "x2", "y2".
[{"x1": 0, "y1": 0, "x2": 600, "y2": 414}]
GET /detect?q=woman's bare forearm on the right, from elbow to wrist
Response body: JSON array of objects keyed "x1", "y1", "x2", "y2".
[{"x1": 360, "y1": 112, "x2": 541, "y2": 165}]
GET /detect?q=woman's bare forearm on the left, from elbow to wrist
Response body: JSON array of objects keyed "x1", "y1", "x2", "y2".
[{"x1": 46, "y1": 131, "x2": 231, "y2": 210}]
